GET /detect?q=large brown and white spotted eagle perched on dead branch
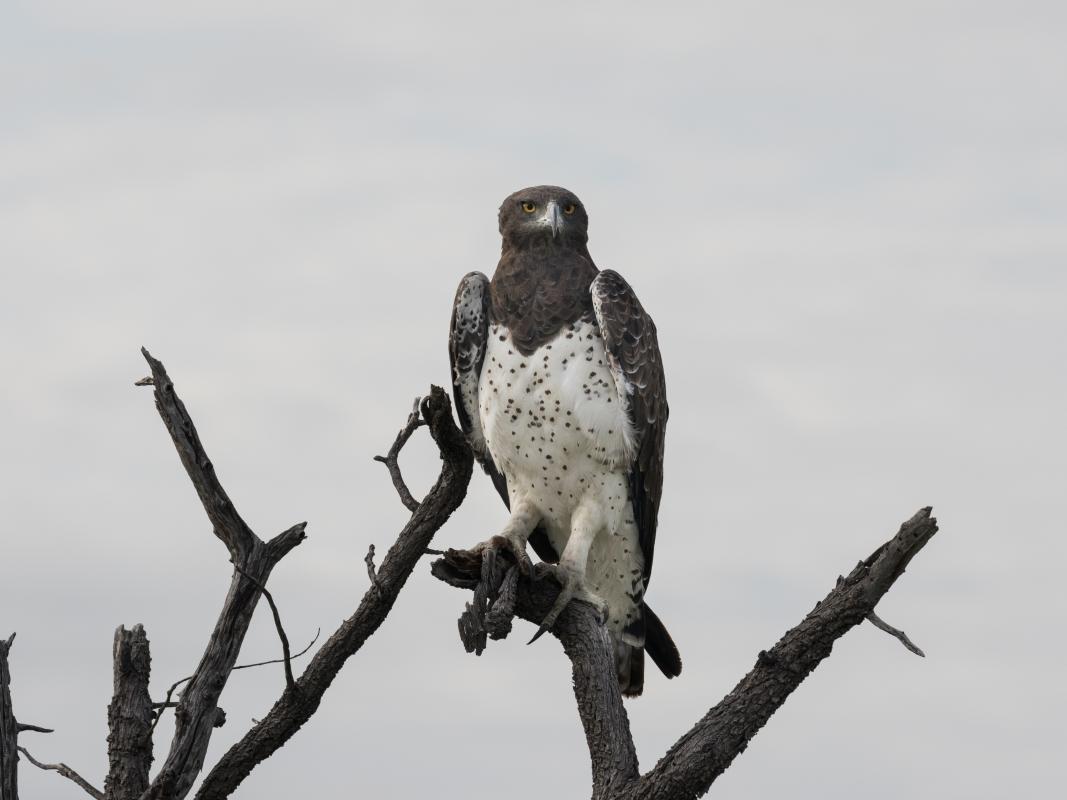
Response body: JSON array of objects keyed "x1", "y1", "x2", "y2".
[{"x1": 448, "y1": 186, "x2": 682, "y2": 695}]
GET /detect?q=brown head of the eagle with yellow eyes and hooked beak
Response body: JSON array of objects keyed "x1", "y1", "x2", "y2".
[{"x1": 500, "y1": 186, "x2": 589, "y2": 250}]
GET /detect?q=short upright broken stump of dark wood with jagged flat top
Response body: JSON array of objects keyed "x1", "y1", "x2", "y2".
[{"x1": 103, "y1": 625, "x2": 153, "y2": 800}]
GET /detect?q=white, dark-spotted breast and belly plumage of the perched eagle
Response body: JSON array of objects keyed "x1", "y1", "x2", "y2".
[{"x1": 478, "y1": 322, "x2": 644, "y2": 636}]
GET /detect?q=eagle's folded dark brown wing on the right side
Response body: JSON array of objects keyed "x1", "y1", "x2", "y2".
[{"x1": 590, "y1": 270, "x2": 669, "y2": 583}]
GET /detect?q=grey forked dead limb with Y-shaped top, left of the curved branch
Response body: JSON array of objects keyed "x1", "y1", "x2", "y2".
[{"x1": 135, "y1": 348, "x2": 306, "y2": 800}]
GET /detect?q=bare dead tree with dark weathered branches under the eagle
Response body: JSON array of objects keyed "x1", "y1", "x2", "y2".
[{"x1": 0, "y1": 351, "x2": 937, "y2": 800}]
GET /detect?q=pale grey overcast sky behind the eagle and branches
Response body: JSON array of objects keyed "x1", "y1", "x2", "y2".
[{"x1": 0, "y1": 0, "x2": 1067, "y2": 800}]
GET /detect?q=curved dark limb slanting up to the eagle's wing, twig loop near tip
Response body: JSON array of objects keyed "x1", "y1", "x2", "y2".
[{"x1": 196, "y1": 386, "x2": 473, "y2": 800}]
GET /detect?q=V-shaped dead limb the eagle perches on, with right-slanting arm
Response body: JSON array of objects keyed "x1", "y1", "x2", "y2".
[{"x1": 432, "y1": 508, "x2": 937, "y2": 800}]
